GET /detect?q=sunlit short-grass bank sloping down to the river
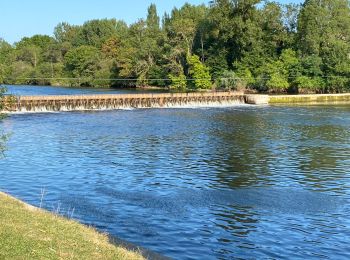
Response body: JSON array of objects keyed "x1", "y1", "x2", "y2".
[{"x1": 0, "y1": 192, "x2": 143, "y2": 259}]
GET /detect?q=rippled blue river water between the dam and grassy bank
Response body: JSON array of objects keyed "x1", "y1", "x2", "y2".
[{"x1": 0, "y1": 85, "x2": 350, "y2": 259}]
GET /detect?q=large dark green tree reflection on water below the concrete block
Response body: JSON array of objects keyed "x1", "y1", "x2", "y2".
[{"x1": 213, "y1": 109, "x2": 272, "y2": 188}]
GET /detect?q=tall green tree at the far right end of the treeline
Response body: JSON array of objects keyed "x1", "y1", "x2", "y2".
[{"x1": 298, "y1": 0, "x2": 350, "y2": 92}]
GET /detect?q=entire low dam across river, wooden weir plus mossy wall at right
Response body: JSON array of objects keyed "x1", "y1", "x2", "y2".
[{"x1": 3, "y1": 92, "x2": 350, "y2": 112}]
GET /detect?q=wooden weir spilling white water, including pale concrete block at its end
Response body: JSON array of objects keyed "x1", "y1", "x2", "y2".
[{"x1": 3, "y1": 92, "x2": 268, "y2": 112}]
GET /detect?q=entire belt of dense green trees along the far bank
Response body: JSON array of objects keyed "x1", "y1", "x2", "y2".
[{"x1": 0, "y1": 0, "x2": 350, "y2": 93}]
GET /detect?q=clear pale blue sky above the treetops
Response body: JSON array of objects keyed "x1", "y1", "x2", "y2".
[{"x1": 0, "y1": 0, "x2": 302, "y2": 43}]
